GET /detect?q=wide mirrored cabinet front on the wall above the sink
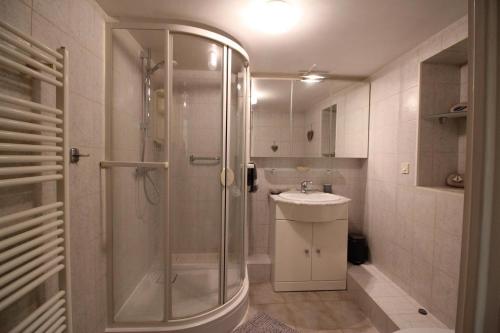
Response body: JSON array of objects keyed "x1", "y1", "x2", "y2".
[{"x1": 250, "y1": 78, "x2": 370, "y2": 158}]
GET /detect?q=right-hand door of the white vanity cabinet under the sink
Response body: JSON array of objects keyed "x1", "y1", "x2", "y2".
[{"x1": 311, "y1": 220, "x2": 347, "y2": 281}]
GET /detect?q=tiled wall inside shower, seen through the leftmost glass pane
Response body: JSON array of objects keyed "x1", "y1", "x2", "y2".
[{"x1": 109, "y1": 30, "x2": 163, "y2": 312}]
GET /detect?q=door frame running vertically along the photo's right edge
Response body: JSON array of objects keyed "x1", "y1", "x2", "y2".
[{"x1": 456, "y1": 0, "x2": 500, "y2": 333}]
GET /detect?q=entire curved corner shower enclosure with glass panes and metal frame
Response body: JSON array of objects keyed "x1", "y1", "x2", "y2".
[{"x1": 101, "y1": 23, "x2": 249, "y2": 327}]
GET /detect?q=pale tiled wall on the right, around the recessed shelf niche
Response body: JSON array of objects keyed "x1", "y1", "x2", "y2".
[{"x1": 363, "y1": 17, "x2": 467, "y2": 327}]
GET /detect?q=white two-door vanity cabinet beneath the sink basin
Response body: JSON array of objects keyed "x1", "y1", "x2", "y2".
[{"x1": 271, "y1": 196, "x2": 347, "y2": 291}]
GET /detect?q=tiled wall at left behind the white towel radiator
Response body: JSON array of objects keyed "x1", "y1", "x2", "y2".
[{"x1": 0, "y1": 0, "x2": 106, "y2": 333}]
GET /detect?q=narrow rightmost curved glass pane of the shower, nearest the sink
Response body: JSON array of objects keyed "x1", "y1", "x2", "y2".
[{"x1": 225, "y1": 50, "x2": 248, "y2": 301}]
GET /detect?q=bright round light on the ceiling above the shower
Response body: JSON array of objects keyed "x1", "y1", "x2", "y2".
[{"x1": 244, "y1": 0, "x2": 300, "y2": 34}]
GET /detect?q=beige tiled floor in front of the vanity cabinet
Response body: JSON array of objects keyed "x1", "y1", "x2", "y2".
[{"x1": 243, "y1": 283, "x2": 378, "y2": 333}]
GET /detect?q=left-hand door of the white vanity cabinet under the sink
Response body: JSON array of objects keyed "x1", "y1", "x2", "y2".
[{"x1": 274, "y1": 220, "x2": 312, "y2": 281}]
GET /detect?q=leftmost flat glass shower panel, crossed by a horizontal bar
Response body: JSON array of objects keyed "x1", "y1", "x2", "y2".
[{"x1": 106, "y1": 29, "x2": 167, "y2": 322}]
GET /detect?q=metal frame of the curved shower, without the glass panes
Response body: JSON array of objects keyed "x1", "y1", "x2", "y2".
[{"x1": 100, "y1": 19, "x2": 250, "y2": 332}]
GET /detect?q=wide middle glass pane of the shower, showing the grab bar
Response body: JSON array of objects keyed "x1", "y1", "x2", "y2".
[{"x1": 169, "y1": 33, "x2": 224, "y2": 319}]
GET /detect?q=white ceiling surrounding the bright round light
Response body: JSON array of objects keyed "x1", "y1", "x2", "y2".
[{"x1": 97, "y1": 0, "x2": 467, "y2": 75}]
